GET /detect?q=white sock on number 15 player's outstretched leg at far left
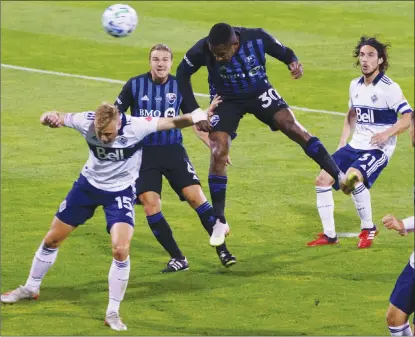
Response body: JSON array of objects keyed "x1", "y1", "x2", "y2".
[{"x1": 25, "y1": 241, "x2": 59, "y2": 293}]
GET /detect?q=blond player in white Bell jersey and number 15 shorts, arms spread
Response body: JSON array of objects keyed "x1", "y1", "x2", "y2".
[{"x1": 1, "y1": 98, "x2": 220, "y2": 331}]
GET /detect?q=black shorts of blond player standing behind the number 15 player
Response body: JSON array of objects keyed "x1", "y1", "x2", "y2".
[{"x1": 136, "y1": 144, "x2": 200, "y2": 203}]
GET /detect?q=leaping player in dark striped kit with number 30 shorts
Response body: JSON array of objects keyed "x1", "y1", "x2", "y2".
[{"x1": 176, "y1": 23, "x2": 340, "y2": 233}]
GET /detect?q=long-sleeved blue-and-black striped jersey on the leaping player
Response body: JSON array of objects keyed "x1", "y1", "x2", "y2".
[{"x1": 176, "y1": 27, "x2": 297, "y2": 112}]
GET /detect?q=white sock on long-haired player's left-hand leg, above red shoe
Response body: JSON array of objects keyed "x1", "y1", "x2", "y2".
[{"x1": 316, "y1": 186, "x2": 336, "y2": 238}]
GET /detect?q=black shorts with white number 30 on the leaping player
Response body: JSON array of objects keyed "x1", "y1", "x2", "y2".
[{"x1": 210, "y1": 87, "x2": 289, "y2": 139}]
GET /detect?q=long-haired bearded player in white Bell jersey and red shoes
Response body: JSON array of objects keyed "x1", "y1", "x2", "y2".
[{"x1": 307, "y1": 36, "x2": 412, "y2": 248}]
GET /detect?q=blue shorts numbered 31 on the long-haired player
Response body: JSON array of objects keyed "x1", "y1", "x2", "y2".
[{"x1": 332, "y1": 144, "x2": 388, "y2": 190}]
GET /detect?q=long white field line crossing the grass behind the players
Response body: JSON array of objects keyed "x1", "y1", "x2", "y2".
[{"x1": 1, "y1": 63, "x2": 345, "y2": 116}]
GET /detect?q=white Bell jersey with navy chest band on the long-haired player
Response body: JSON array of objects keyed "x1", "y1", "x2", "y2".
[{"x1": 349, "y1": 73, "x2": 412, "y2": 159}]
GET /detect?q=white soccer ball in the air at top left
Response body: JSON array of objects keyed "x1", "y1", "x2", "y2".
[{"x1": 102, "y1": 4, "x2": 138, "y2": 37}]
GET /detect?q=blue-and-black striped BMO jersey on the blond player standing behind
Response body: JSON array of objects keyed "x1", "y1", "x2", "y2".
[{"x1": 114, "y1": 72, "x2": 183, "y2": 146}]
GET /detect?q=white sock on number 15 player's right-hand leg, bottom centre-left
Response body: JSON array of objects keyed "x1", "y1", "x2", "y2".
[{"x1": 107, "y1": 256, "x2": 130, "y2": 314}]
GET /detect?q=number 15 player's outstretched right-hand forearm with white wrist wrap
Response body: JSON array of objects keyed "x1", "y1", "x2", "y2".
[{"x1": 157, "y1": 96, "x2": 222, "y2": 131}]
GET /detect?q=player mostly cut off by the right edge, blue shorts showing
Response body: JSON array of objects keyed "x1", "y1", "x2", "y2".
[{"x1": 382, "y1": 111, "x2": 415, "y2": 336}]
